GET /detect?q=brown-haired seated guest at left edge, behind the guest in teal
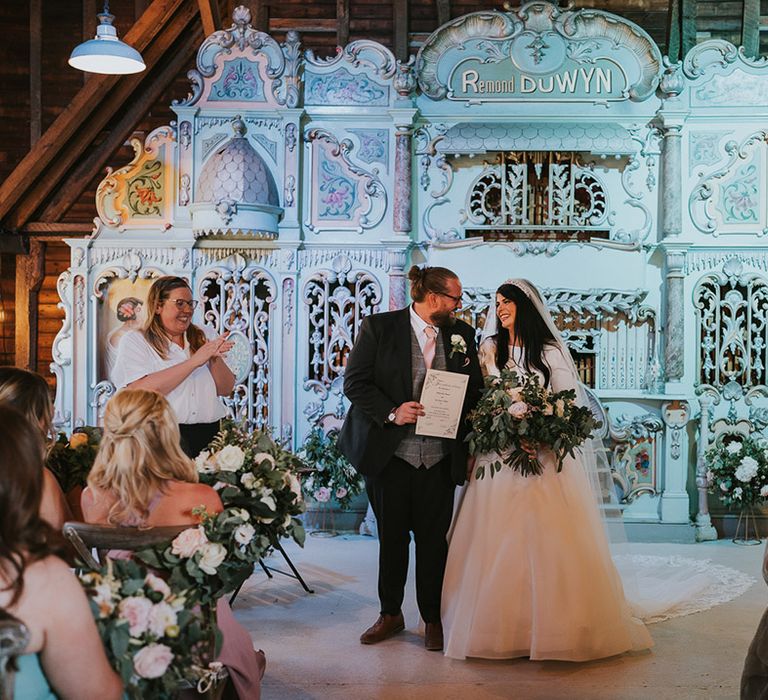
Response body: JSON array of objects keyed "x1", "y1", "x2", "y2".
[{"x1": 0, "y1": 367, "x2": 72, "y2": 530}]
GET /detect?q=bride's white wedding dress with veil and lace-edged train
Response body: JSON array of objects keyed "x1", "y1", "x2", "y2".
[{"x1": 441, "y1": 280, "x2": 755, "y2": 661}]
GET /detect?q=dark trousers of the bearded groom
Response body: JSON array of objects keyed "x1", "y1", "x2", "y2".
[{"x1": 365, "y1": 456, "x2": 455, "y2": 622}]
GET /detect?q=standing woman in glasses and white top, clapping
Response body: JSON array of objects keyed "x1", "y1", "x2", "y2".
[{"x1": 112, "y1": 277, "x2": 235, "y2": 458}]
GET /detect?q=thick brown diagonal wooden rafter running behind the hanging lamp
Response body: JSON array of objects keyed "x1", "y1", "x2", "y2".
[{"x1": 0, "y1": 0, "x2": 192, "y2": 227}]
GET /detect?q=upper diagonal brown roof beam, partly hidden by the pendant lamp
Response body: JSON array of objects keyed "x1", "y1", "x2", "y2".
[{"x1": 0, "y1": 0, "x2": 188, "y2": 226}]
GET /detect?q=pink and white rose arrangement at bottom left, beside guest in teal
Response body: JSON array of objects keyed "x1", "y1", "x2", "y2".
[{"x1": 80, "y1": 559, "x2": 220, "y2": 700}]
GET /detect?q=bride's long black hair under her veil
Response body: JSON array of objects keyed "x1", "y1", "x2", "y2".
[{"x1": 493, "y1": 284, "x2": 556, "y2": 386}]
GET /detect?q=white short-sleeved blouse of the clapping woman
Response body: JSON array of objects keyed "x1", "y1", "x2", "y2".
[{"x1": 111, "y1": 327, "x2": 228, "y2": 423}]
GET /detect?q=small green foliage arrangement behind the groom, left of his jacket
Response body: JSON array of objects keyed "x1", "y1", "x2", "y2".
[{"x1": 300, "y1": 428, "x2": 365, "y2": 510}]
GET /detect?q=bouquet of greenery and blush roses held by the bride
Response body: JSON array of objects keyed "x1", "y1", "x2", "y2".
[{"x1": 467, "y1": 369, "x2": 598, "y2": 479}]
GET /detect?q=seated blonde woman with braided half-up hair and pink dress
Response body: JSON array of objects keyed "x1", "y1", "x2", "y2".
[{"x1": 82, "y1": 389, "x2": 265, "y2": 700}]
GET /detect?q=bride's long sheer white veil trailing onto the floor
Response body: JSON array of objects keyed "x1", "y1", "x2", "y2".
[{"x1": 480, "y1": 279, "x2": 754, "y2": 622}]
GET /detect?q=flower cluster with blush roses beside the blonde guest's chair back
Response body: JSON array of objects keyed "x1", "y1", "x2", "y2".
[{"x1": 135, "y1": 507, "x2": 270, "y2": 606}]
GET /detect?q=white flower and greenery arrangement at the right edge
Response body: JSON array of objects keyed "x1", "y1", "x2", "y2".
[{"x1": 705, "y1": 437, "x2": 768, "y2": 506}]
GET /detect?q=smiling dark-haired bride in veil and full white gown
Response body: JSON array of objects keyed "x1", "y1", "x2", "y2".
[{"x1": 442, "y1": 280, "x2": 653, "y2": 661}]
